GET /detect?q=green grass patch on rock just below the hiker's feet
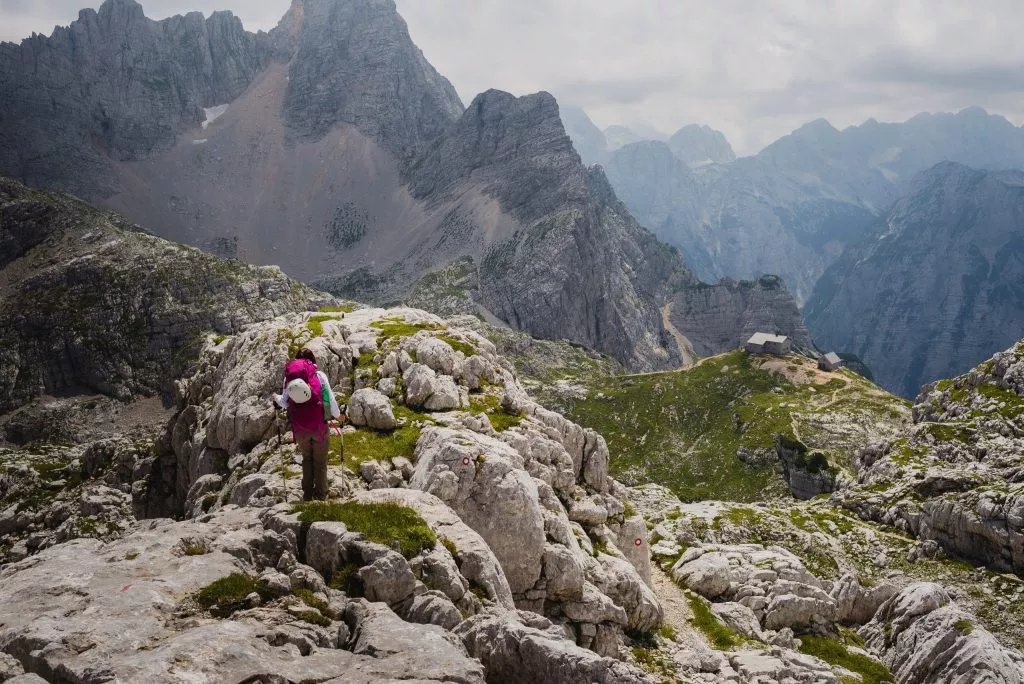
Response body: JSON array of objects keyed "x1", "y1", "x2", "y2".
[{"x1": 293, "y1": 501, "x2": 437, "y2": 558}]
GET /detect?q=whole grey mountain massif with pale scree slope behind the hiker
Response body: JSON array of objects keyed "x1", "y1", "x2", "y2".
[{"x1": 0, "y1": 0, "x2": 810, "y2": 370}]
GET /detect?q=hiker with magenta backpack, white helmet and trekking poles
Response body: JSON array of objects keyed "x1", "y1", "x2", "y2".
[{"x1": 273, "y1": 348, "x2": 342, "y2": 501}]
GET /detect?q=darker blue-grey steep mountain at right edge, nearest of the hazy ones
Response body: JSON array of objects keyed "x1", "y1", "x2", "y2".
[{"x1": 805, "y1": 163, "x2": 1024, "y2": 396}]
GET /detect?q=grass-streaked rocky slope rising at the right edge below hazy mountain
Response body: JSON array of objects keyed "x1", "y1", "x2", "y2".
[{"x1": 837, "y1": 345, "x2": 1024, "y2": 572}]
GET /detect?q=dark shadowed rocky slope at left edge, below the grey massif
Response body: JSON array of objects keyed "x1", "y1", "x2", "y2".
[{"x1": 0, "y1": 178, "x2": 330, "y2": 413}]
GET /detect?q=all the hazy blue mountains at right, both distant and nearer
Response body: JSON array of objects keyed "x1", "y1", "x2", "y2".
[{"x1": 565, "y1": 108, "x2": 1024, "y2": 396}]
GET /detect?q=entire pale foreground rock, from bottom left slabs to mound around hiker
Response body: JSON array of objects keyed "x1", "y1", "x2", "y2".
[{"x1": 0, "y1": 309, "x2": 662, "y2": 682}]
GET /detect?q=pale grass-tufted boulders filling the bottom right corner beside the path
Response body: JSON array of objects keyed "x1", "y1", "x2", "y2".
[{"x1": 631, "y1": 485, "x2": 1024, "y2": 682}]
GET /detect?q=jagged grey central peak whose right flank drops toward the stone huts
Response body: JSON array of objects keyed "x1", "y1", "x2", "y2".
[{"x1": 410, "y1": 91, "x2": 693, "y2": 368}]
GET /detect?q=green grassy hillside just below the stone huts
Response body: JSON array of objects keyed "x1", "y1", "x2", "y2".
[{"x1": 568, "y1": 351, "x2": 908, "y2": 502}]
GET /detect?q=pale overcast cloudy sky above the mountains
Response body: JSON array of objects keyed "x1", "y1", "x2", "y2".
[{"x1": 0, "y1": 0, "x2": 1024, "y2": 154}]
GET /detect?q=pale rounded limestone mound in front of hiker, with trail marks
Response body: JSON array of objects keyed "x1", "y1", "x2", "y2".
[{"x1": 148, "y1": 309, "x2": 663, "y2": 658}]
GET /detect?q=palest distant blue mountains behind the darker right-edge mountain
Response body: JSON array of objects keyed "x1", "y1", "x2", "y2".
[{"x1": 574, "y1": 108, "x2": 1024, "y2": 303}]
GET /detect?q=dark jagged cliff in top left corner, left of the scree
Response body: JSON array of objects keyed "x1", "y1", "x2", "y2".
[{"x1": 0, "y1": 0, "x2": 267, "y2": 199}]
